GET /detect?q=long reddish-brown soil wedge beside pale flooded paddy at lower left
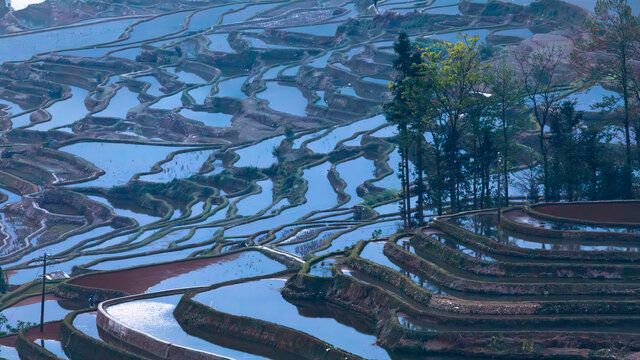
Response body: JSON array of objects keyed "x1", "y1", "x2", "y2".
[{"x1": 70, "y1": 254, "x2": 239, "y2": 294}]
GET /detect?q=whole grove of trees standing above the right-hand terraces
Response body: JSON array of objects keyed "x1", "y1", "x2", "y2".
[{"x1": 385, "y1": 0, "x2": 640, "y2": 227}]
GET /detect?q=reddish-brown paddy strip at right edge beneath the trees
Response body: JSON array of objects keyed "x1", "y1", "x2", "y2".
[{"x1": 534, "y1": 203, "x2": 640, "y2": 223}]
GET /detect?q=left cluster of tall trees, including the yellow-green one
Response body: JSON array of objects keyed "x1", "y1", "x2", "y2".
[{"x1": 385, "y1": 34, "x2": 504, "y2": 218}]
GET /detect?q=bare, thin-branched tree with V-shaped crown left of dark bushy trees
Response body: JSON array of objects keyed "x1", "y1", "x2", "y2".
[{"x1": 515, "y1": 46, "x2": 563, "y2": 200}]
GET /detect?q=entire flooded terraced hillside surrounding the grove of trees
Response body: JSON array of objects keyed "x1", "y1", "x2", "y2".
[{"x1": 0, "y1": 0, "x2": 640, "y2": 359}]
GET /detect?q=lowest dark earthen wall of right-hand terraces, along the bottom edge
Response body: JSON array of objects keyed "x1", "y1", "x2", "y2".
[{"x1": 283, "y1": 268, "x2": 640, "y2": 359}]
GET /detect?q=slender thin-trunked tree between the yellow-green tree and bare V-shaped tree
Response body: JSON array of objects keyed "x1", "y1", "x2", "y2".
[{"x1": 488, "y1": 59, "x2": 522, "y2": 206}]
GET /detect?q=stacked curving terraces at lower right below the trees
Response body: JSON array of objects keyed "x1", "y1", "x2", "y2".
[{"x1": 282, "y1": 202, "x2": 640, "y2": 358}]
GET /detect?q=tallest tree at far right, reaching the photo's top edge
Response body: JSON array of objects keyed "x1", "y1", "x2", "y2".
[{"x1": 573, "y1": 0, "x2": 640, "y2": 198}]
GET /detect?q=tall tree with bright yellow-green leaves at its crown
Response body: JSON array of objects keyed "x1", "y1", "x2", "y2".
[{"x1": 405, "y1": 34, "x2": 488, "y2": 212}]
